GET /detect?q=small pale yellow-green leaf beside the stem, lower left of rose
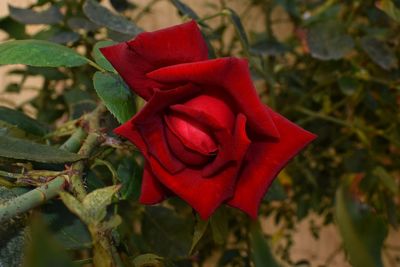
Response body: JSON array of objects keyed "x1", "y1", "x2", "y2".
[{"x1": 82, "y1": 185, "x2": 121, "y2": 223}]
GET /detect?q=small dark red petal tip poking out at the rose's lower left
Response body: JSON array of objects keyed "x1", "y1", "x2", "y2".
[{"x1": 139, "y1": 163, "x2": 167, "y2": 205}]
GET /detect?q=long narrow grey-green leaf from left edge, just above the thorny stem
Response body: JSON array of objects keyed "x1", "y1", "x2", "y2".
[{"x1": 0, "y1": 136, "x2": 83, "y2": 163}]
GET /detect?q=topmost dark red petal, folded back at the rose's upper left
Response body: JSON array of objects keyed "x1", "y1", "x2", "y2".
[{"x1": 100, "y1": 21, "x2": 208, "y2": 100}]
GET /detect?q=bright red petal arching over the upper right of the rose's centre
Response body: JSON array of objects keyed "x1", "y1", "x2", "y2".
[{"x1": 147, "y1": 58, "x2": 279, "y2": 138}]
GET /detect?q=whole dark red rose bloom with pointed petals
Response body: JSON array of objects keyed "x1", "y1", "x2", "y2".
[{"x1": 101, "y1": 21, "x2": 315, "y2": 219}]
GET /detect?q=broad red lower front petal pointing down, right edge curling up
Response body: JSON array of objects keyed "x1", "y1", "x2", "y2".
[{"x1": 150, "y1": 115, "x2": 249, "y2": 220}]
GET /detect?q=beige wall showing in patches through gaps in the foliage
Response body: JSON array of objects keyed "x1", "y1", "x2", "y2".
[{"x1": 0, "y1": 0, "x2": 400, "y2": 267}]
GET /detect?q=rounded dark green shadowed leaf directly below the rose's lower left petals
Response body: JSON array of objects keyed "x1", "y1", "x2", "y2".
[{"x1": 142, "y1": 206, "x2": 193, "y2": 258}]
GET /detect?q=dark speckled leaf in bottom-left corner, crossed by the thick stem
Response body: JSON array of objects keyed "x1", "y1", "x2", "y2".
[{"x1": 0, "y1": 187, "x2": 27, "y2": 266}]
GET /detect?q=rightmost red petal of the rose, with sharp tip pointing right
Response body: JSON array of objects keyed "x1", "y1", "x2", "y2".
[{"x1": 228, "y1": 110, "x2": 316, "y2": 218}]
